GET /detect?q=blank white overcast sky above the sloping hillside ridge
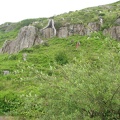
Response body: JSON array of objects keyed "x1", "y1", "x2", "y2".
[{"x1": 0, "y1": 0, "x2": 119, "y2": 24}]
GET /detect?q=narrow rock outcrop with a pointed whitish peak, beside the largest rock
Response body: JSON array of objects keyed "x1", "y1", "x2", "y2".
[{"x1": 40, "y1": 19, "x2": 56, "y2": 38}]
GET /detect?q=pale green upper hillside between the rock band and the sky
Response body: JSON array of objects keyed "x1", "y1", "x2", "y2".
[{"x1": 0, "y1": 1, "x2": 120, "y2": 47}]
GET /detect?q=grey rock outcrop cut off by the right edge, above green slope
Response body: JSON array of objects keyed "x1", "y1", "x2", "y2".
[{"x1": 103, "y1": 26, "x2": 120, "y2": 40}]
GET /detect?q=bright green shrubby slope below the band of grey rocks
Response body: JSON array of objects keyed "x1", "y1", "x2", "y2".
[{"x1": 0, "y1": 32, "x2": 120, "y2": 120}]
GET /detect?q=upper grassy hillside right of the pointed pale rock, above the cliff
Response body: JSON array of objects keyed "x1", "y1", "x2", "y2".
[{"x1": 54, "y1": 1, "x2": 120, "y2": 29}]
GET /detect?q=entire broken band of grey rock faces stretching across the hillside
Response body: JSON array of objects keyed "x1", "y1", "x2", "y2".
[{"x1": 0, "y1": 19, "x2": 120, "y2": 54}]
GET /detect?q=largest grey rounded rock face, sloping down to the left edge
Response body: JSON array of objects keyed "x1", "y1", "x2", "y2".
[{"x1": 1, "y1": 26, "x2": 42, "y2": 54}]
